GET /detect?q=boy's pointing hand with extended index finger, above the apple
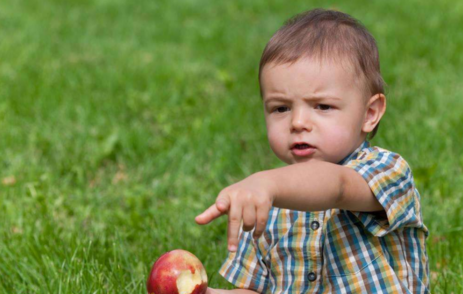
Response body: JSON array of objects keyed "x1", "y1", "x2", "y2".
[{"x1": 195, "y1": 172, "x2": 275, "y2": 252}]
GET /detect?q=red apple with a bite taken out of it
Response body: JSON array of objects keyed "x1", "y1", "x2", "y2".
[{"x1": 147, "y1": 249, "x2": 207, "y2": 294}]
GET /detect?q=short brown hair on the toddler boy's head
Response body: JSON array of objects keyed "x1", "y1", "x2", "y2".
[{"x1": 259, "y1": 9, "x2": 385, "y2": 138}]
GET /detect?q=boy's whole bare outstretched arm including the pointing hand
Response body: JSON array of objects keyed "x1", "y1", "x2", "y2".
[{"x1": 196, "y1": 160, "x2": 383, "y2": 252}]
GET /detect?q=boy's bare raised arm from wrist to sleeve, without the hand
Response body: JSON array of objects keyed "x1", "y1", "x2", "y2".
[{"x1": 264, "y1": 161, "x2": 383, "y2": 212}]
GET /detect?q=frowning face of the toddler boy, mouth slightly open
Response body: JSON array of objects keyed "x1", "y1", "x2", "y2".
[{"x1": 261, "y1": 58, "x2": 367, "y2": 164}]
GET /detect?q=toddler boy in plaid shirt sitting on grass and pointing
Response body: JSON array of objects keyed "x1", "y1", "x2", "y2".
[{"x1": 196, "y1": 9, "x2": 429, "y2": 293}]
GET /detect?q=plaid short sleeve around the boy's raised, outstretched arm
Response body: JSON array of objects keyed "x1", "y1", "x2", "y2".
[{"x1": 345, "y1": 148, "x2": 424, "y2": 237}]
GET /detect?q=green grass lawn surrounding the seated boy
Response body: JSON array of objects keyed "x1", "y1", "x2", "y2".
[{"x1": 0, "y1": 0, "x2": 463, "y2": 293}]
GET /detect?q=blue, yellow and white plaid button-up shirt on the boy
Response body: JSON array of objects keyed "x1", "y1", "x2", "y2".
[{"x1": 219, "y1": 141, "x2": 429, "y2": 293}]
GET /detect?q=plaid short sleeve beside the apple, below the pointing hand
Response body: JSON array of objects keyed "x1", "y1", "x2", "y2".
[{"x1": 219, "y1": 231, "x2": 268, "y2": 293}]
